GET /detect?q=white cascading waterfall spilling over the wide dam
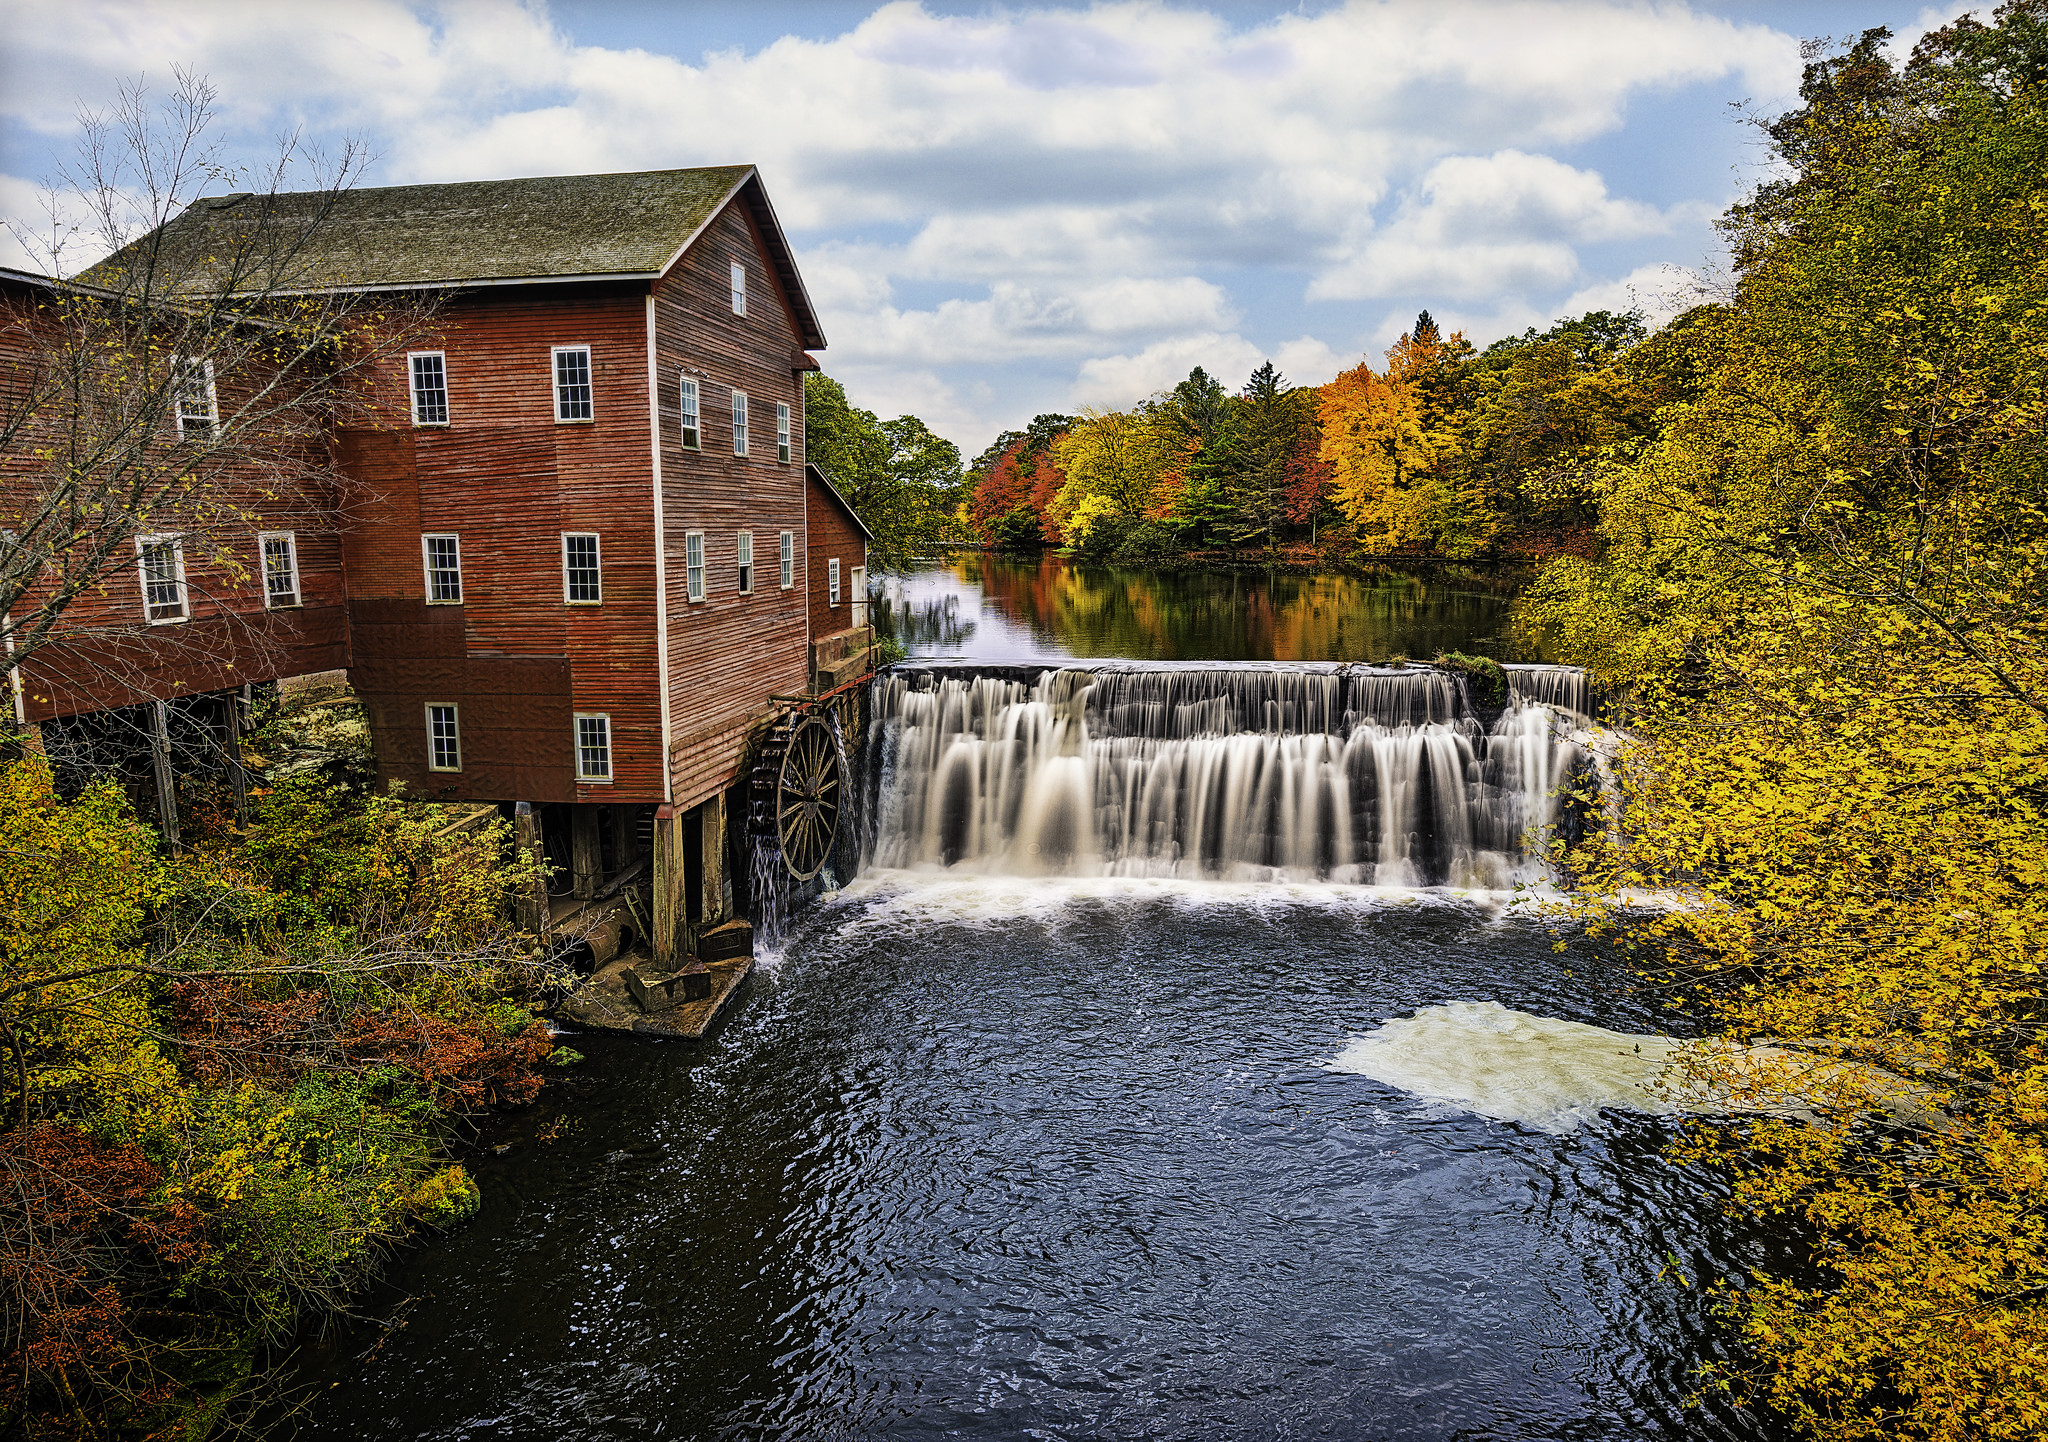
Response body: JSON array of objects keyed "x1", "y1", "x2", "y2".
[{"x1": 866, "y1": 666, "x2": 1591, "y2": 889}]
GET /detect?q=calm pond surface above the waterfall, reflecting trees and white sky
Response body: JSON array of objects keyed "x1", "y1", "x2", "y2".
[{"x1": 872, "y1": 553, "x2": 1544, "y2": 664}]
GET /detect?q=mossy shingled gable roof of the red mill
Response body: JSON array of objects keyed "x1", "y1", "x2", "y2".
[{"x1": 80, "y1": 166, "x2": 825, "y2": 350}]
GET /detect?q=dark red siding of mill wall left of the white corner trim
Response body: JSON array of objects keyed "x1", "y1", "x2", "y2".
[{"x1": 344, "y1": 287, "x2": 662, "y2": 801}]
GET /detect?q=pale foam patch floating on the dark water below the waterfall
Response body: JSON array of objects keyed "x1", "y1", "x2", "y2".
[{"x1": 1325, "y1": 1002, "x2": 1681, "y2": 1135}]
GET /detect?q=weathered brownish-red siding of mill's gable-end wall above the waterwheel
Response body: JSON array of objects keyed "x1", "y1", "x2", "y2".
[{"x1": 653, "y1": 205, "x2": 809, "y2": 807}]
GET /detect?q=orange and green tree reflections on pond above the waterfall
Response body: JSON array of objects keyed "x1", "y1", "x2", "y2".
[{"x1": 961, "y1": 555, "x2": 1520, "y2": 662}]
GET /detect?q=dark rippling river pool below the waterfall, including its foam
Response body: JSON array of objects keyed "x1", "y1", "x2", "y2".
[{"x1": 299, "y1": 561, "x2": 1780, "y2": 1442}]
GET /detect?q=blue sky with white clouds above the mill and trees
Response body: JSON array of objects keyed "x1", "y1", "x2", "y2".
[{"x1": 0, "y1": 0, "x2": 1989, "y2": 455}]
